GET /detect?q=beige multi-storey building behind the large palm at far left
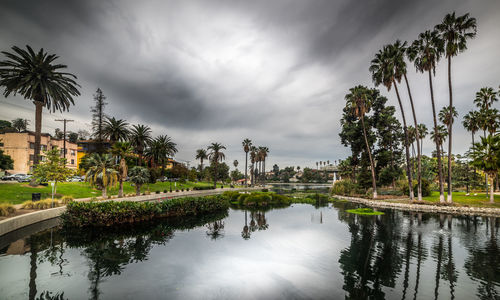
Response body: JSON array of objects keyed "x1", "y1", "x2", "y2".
[{"x1": 0, "y1": 131, "x2": 78, "y2": 174}]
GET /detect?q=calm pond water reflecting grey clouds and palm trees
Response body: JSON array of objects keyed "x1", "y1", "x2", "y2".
[{"x1": 0, "y1": 202, "x2": 500, "y2": 299}]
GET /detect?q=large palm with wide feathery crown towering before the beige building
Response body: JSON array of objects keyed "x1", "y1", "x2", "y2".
[{"x1": 0, "y1": 46, "x2": 80, "y2": 165}]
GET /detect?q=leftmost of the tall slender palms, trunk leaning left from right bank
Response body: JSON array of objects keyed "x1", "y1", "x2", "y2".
[{"x1": 369, "y1": 45, "x2": 414, "y2": 201}]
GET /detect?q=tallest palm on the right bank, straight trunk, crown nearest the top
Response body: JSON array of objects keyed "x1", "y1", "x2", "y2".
[{"x1": 435, "y1": 12, "x2": 477, "y2": 203}]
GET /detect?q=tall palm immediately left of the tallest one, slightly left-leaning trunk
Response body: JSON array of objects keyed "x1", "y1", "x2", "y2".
[{"x1": 407, "y1": 30, "x2": 445, "y2": 203}]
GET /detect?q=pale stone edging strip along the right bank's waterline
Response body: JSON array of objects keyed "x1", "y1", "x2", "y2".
[{"x1": 332, "y1": 195, "x2": 500, "y2": 217}]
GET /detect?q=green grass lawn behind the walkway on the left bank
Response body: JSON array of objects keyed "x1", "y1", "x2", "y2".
[{"x1": 0, "y1": 182, "x2": 229, "y2": 204}]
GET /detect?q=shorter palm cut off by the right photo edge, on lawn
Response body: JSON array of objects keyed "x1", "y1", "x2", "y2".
[{"x1": 471, "y1": 135, "x2": 500, "y2": 203}]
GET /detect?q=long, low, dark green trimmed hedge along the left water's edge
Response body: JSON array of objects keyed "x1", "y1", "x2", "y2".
[{"x1": 61, "y1": 196, "x2": 229, "y2": 227}]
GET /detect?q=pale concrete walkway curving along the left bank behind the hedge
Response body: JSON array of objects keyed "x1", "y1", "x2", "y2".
[{"x1": 0, "y1": 187, "x2": 262, "y2": 237}]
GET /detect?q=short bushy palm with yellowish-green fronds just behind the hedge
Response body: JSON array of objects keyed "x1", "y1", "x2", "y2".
[{"x1": 85, "y1": 153, "x2": 118, "y2": 198}]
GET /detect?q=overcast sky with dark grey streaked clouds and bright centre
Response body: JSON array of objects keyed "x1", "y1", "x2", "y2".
[{"x1": 0, "y1": 0, "x2": 500, "y2": 170}]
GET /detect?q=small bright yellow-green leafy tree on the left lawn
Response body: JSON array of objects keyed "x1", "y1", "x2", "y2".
[{"x1": 33, "y1": 147, "x2": 74, "y2": 193}]
